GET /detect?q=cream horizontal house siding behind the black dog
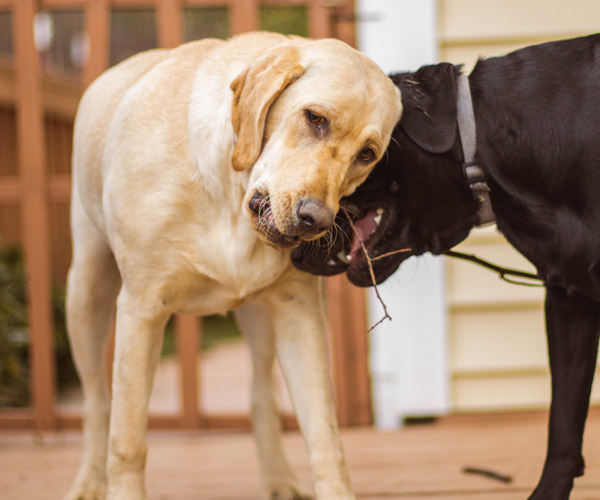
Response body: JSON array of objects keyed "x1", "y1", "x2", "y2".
[{"x1": 438, "y1": 0, "x2": 600, "y2": 412}]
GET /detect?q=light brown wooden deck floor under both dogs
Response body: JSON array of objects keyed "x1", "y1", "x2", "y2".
[{"x1": 0, "y1": 410, "x2": 600, "y2": 500}]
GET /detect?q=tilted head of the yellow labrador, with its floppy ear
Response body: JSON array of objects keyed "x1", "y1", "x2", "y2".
[{"x1": 231, "y1": 38, "x2": 402, "y2": 248}]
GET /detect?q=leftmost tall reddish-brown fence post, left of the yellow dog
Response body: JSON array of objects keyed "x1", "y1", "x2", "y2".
[{"x1": 13, "y1": 0, "x2": 56, "y2": 429}]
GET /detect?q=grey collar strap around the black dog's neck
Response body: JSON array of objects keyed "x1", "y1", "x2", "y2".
[{"x1": 456, "y1": 75, "x2": 496, "y2": 227}]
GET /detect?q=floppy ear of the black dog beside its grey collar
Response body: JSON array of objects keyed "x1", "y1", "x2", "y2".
[{"x1": 391, "y1": 63, "x2": 458, "y2": 153}]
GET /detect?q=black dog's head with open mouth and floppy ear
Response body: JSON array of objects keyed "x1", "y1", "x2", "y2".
[{"x1": 292, "y1": 63, "x2": 477, "y2": 286}]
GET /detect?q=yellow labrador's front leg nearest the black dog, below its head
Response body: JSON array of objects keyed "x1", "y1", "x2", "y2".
[{"x1": 269, "y1": 272, "x2": 354, "y2": 500}]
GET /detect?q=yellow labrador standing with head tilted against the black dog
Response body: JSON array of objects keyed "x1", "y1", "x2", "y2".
[{"x1": 66, "y1": 33, "x2": 401, "y2": 500}]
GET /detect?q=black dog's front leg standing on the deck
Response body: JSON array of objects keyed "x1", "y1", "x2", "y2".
[{"x1": 529, "y1": 287, "x2": 600, "y2": 500}]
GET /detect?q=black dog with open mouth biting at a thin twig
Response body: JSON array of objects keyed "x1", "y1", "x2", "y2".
[{"x1": 293, "y1": 34, "x2": 600, "y2": 500}]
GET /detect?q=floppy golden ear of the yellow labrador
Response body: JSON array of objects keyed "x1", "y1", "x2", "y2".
[{"x1": 230, "y1": 47, "x2": 306, "y2": 172}]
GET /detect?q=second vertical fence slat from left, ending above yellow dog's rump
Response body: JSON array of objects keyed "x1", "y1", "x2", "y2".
[{"x1": 83, "y1": 0, "x2": 110, "y2": 86}]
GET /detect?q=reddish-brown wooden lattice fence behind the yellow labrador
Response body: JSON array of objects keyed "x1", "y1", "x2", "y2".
[{"x1": 0, "y1": 0, "x2": 371, "y2": 430}]
